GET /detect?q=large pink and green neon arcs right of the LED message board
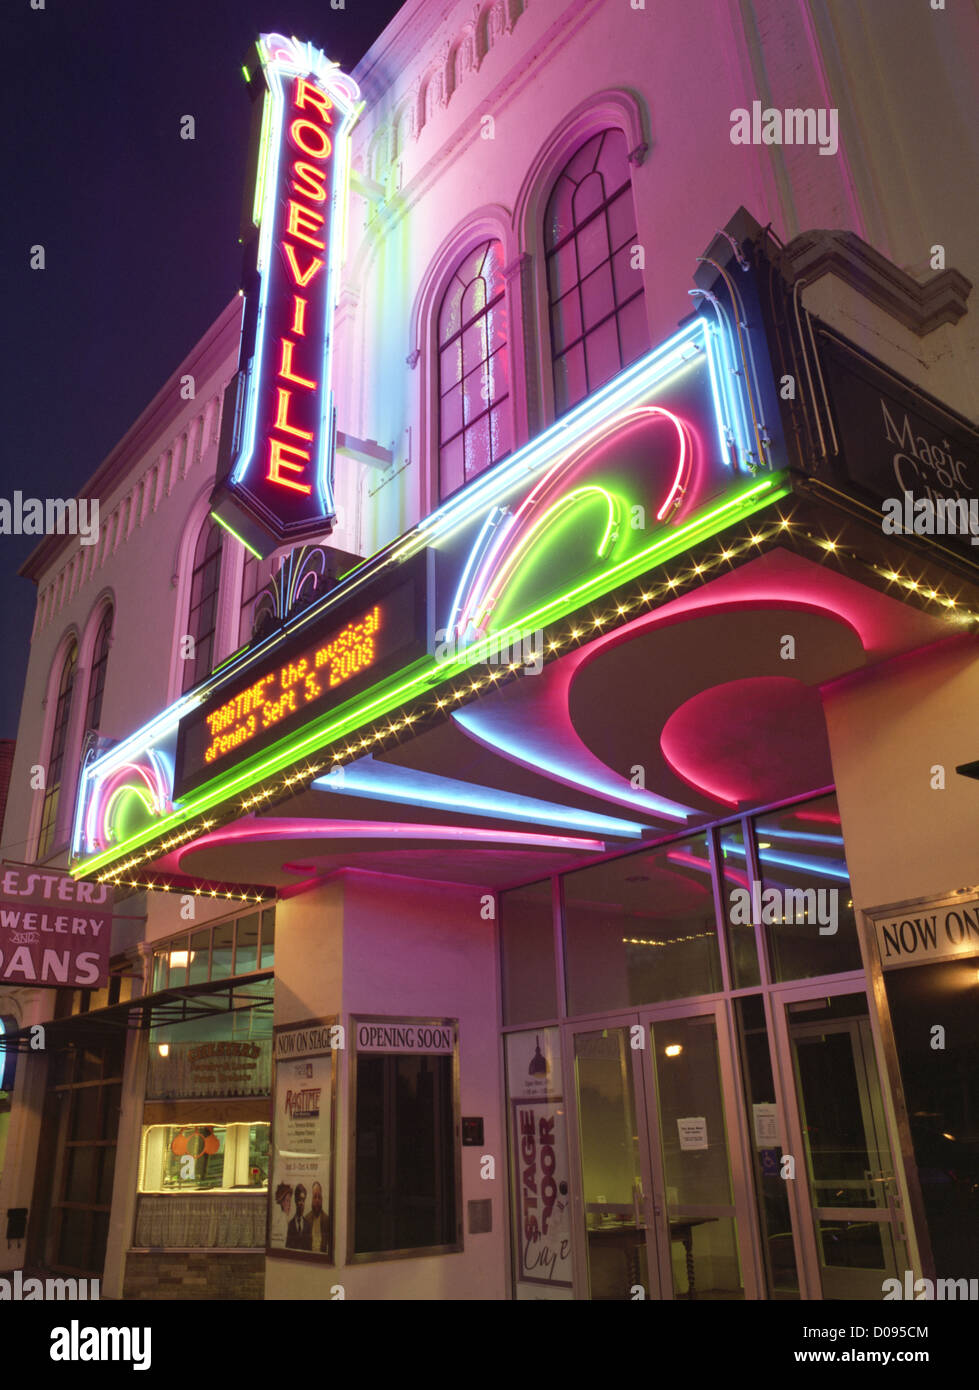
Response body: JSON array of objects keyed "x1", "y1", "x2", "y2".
[{"x1": 446, "y1": 406, "x2": 693, "y2": 639}]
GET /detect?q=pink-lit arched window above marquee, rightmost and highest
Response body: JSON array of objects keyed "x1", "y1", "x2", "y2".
[{"x1": 544, "y1": 129, "x2": 649, "y2": 414}]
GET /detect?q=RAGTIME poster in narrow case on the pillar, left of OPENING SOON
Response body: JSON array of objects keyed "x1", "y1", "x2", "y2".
[{"x1": 268, "y1": 1020, "x2": 339, "y2": 1259}]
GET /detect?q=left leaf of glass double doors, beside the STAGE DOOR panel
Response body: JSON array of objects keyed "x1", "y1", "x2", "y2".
[{"x1": 566, "y1": 1015, "x2": 661, "y2": 1301}]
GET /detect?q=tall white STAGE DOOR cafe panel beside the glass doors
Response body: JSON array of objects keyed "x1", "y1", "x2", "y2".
[{"x1": 506, "y1": 1029, "x2": 573, "y2": 1290}]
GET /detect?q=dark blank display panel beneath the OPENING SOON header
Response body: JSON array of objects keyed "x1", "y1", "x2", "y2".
[{"x1": 352, "y1": 1023, "x2": 462, "y2": 1259}]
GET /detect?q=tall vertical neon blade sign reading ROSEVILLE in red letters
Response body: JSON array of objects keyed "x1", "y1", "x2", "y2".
[{"x1": 211, "y1": 33, "x2": 360, "y2": 555}]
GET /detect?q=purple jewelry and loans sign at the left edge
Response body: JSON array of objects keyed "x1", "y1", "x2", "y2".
[{"x1": 0, "y1": 865, "x2": 113, "y2": 990}]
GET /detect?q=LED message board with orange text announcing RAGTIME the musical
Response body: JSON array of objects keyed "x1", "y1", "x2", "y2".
[{"x1": 174, "y1": 556, "x2": 427, "y2": 799}]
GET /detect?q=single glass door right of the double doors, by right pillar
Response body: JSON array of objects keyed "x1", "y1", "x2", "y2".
[{"x1": 776, "y1": 990, "x2": 908, "y2": 1300}]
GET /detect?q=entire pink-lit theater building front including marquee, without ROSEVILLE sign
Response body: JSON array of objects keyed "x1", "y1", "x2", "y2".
[{"x1": 0, "y1": 0, "x2": 979, "y2": 1300}]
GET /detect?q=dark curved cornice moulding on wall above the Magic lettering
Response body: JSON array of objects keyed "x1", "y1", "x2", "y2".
[{"x1": 780, "y1": 231, "x2": 972, "y2": 338}]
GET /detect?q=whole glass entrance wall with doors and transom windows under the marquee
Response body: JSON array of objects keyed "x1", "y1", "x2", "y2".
[{"x1": 499, "y1": 794, "x2": 907, "y2": 1301}]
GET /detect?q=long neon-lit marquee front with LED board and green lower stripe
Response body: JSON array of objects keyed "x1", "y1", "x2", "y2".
[{"x1": 72, "y1": 286, "x2": 790, "y2": 874}]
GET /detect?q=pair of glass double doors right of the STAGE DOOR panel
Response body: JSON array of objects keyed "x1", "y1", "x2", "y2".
[{"x1": 566, "y1": 1002, "x2": 757, "y2": 1301}]
